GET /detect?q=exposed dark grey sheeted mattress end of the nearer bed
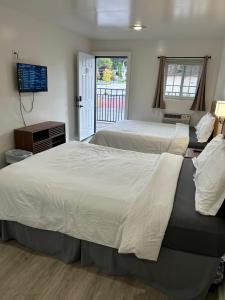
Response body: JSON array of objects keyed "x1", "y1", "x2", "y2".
[{"x1": 163, "y1": 158, "x2": 225, "y2": 257}]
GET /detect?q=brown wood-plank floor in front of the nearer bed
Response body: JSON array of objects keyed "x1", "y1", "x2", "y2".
[{"x1": 0, "y1": 241, "x2": 216, "y2": 300}]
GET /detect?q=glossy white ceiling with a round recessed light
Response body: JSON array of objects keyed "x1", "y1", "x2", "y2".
[{"x1": 0, "y1": 0, "x2": 225, "y2": 39}]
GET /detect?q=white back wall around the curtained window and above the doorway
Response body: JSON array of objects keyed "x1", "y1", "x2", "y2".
[{"x1": 92, "y1": 40, "x2": 223, "y2": 123}]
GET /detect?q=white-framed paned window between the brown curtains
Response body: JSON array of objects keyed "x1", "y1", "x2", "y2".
[{"x1": 164, "y1": 61, "x2": 202, "y2": 99}]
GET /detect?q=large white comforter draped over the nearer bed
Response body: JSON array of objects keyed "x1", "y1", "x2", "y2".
[{"x1": 0, "y1": 142, "x2": 182, "y2": 260}]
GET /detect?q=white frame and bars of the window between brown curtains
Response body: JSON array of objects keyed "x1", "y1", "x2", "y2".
[{"x1": 163, "y1": 59, "x2": 202, "y2": 101}]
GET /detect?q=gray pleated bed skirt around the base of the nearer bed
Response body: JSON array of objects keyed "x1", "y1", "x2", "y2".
[{"x1": 0, "y1": 221, "x2": 220, "y2": 300}]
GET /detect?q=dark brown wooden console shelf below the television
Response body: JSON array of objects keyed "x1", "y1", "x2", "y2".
[{"x1": 14, "y1": 121, "x2": 66, "y2": 154}]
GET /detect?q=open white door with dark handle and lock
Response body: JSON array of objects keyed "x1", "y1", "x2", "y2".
[{"x1": 76, "y1": 52, "x2": 95, "y2": 141}]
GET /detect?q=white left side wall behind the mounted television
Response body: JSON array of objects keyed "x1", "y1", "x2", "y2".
[{"x1": 0, "y1": 6, "x2": 89, "y2": 167}]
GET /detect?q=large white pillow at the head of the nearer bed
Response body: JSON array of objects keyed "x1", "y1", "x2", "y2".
[{"x1": 194, "y1": 136, "x2": 225, "y2": 216}]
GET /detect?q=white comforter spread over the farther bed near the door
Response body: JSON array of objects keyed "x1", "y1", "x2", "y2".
[{"x1": 90, "y1": 120, "x2": 189, "y2": 155}]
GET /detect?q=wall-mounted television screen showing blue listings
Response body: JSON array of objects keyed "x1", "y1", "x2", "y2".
[{"x1": 17, "y1": 63, "x2": 48, "y2": 93}]
